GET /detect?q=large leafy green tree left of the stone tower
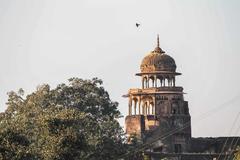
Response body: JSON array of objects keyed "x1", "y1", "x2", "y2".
[{"x1": 0, "y1": 78, "x2": 127, "y2": 160}]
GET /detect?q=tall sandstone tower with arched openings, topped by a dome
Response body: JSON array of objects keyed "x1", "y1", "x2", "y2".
[{"x1": 125, "y1": 36, "x2": 191, "y2": 152}]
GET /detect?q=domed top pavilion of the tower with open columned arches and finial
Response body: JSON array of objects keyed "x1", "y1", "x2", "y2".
[{"x1": 136, "y1": 37, "x2": 181, "y2": 89}]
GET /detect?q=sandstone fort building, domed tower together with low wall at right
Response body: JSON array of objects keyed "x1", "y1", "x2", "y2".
[{"x1": 124, "y1": 37, "x2": 240, "y2": 160}]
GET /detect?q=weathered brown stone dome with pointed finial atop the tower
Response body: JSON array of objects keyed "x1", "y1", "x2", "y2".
[{"x1": 140, "y1": 36, "x2": 176, "y2": 73}]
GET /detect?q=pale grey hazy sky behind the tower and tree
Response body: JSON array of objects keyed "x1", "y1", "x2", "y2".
[{"x1": 0, "y1": 0, "x2": 240, "y2": 136}]
